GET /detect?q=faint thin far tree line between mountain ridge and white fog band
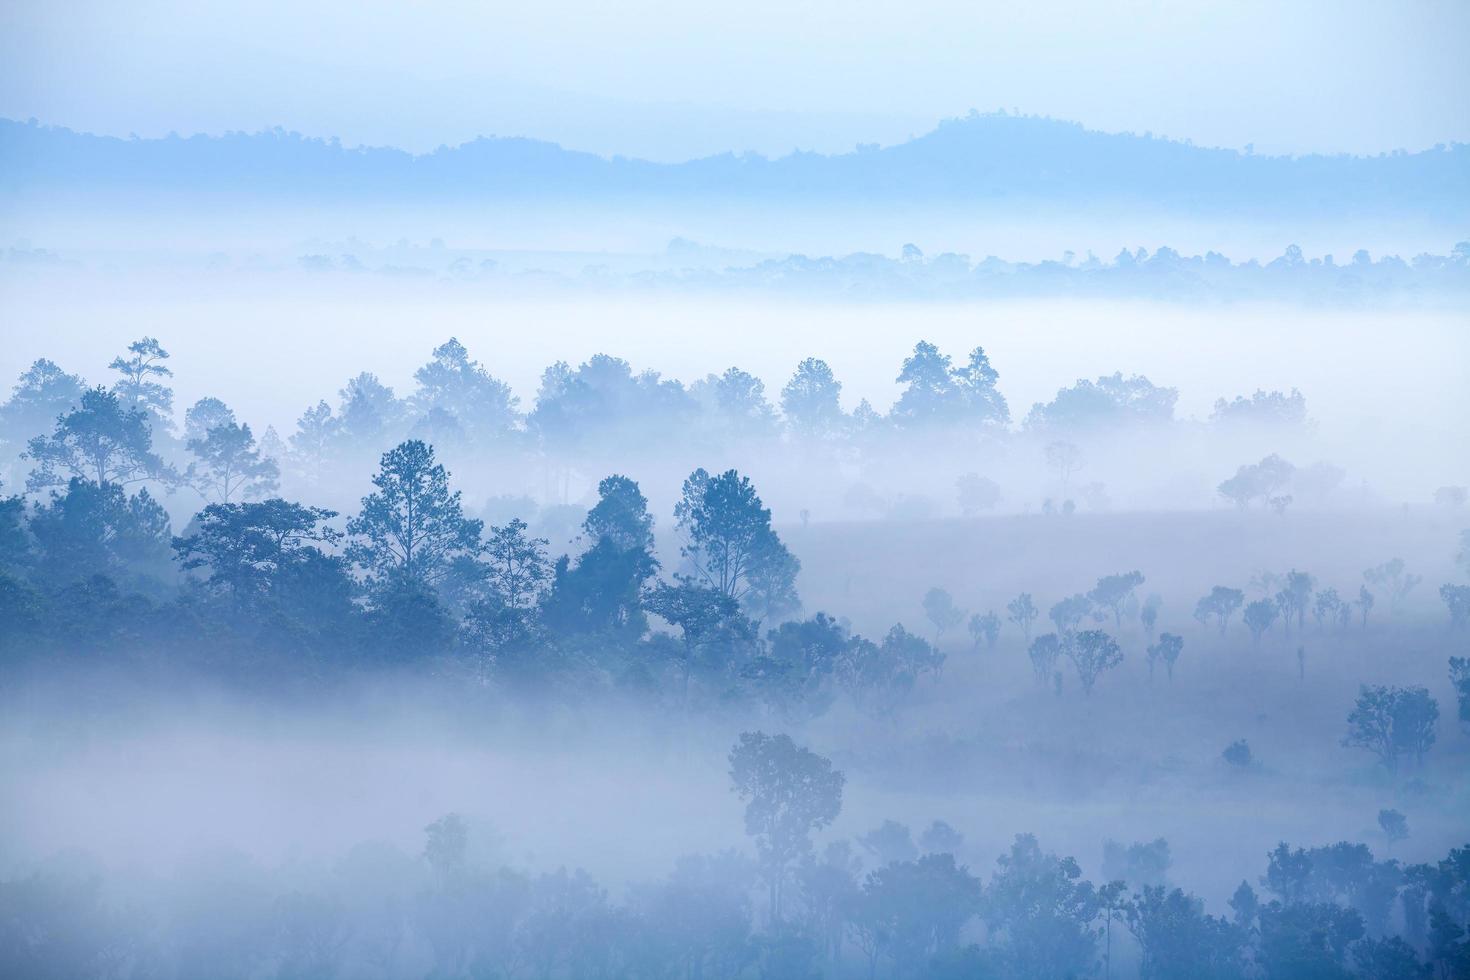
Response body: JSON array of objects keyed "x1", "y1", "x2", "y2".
[{"x1": 11, "y1": 238, "x2": 1470, "y2": 307}]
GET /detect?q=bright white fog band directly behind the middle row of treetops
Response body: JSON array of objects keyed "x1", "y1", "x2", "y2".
[{"x1": 0, "y1": 270, "x2": 1470, "y2": 502}]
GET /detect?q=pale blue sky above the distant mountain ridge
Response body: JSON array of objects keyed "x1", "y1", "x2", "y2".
[{"x1": 0, "y1": 0, "x2": 1470, "y2": 159}]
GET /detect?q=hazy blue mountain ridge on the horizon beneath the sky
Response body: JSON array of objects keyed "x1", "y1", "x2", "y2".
[{"x1": 0, "y1": 113, "x2": 1470, "y2": 215}]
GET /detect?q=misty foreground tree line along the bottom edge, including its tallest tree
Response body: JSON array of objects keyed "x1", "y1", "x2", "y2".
[{"x1": 0, "y1": 732, "x2": 1470, "y2": 980}]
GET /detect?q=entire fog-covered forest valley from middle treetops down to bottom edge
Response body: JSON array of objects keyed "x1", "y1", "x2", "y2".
[{"x1": 0, "y1": 327, "x2": 1470, "y2": 977}]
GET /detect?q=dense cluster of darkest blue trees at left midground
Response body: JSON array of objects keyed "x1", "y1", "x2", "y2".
[{"x1": 0, "y1": 347, "x2": 942, "y2": 717}]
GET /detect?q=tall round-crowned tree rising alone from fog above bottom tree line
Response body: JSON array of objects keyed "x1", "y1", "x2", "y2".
[{"x1": 729, "y1": 732, "x2": 847, "y2": 921}]
